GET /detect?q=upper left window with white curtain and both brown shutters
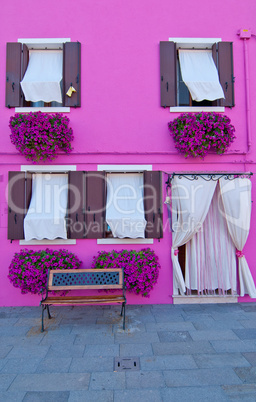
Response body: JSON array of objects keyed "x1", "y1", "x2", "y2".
[{"x1": 6, "y1": 38, "x2": 81, "y2": 112}]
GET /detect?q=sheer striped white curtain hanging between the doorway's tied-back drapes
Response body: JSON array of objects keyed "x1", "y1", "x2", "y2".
[{"x1": 185, "y1": 184, "x2": 237, "y2": 294}]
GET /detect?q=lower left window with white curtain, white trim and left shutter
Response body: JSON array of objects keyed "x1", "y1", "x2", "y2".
[{"x1": 8, "y1": 165, "x2": 76, "y2": 245}]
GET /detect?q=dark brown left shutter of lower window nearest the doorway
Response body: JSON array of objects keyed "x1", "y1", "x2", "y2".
[{"x1": 86, "y1": 172, "x2": 106, "y2": 239}]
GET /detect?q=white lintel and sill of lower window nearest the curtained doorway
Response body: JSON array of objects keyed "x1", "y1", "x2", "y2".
[{"x1": 97, "y1": 165, "x2": 154, "y2": 244}]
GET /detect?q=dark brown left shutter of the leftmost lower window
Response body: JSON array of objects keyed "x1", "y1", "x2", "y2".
[{"x1": 8, "y1": 172, "x2": 32, "y2": 240}]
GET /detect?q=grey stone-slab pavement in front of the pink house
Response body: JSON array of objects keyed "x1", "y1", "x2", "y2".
[{"x1": 0, "y1": 303, "x2": 256, "y2": 402}]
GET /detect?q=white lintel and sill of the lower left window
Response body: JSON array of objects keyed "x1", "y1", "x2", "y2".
[{"x1": 19, "y1": 165, "x2": 76, "y2": 246}]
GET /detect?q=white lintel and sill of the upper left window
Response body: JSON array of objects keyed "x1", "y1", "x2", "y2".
[{"x1": 15, "y1": 38, "x2": 71, "y2": 113}]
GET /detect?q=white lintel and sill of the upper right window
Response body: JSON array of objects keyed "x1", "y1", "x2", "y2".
[{"x1": 169, "y1": 38, "x2": 225, "y2": 113}]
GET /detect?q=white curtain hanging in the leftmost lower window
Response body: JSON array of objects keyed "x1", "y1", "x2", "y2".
[{"x1": 24, "y1": 173, "x2": 68, "y2": 240}]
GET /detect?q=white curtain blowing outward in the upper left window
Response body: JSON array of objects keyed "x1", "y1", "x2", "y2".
[{"x1": 20, "y1": 50, "x2": 63, "y2": 103}]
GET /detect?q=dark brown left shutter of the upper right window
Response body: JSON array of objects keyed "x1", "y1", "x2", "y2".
[{"x1": 160, "y1": 42, "x2": 177, "y2": 107}]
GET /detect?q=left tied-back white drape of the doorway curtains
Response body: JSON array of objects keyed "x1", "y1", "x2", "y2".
[{"x1": 172, "y1": 176, "x2": 216, "y2": 294}]
